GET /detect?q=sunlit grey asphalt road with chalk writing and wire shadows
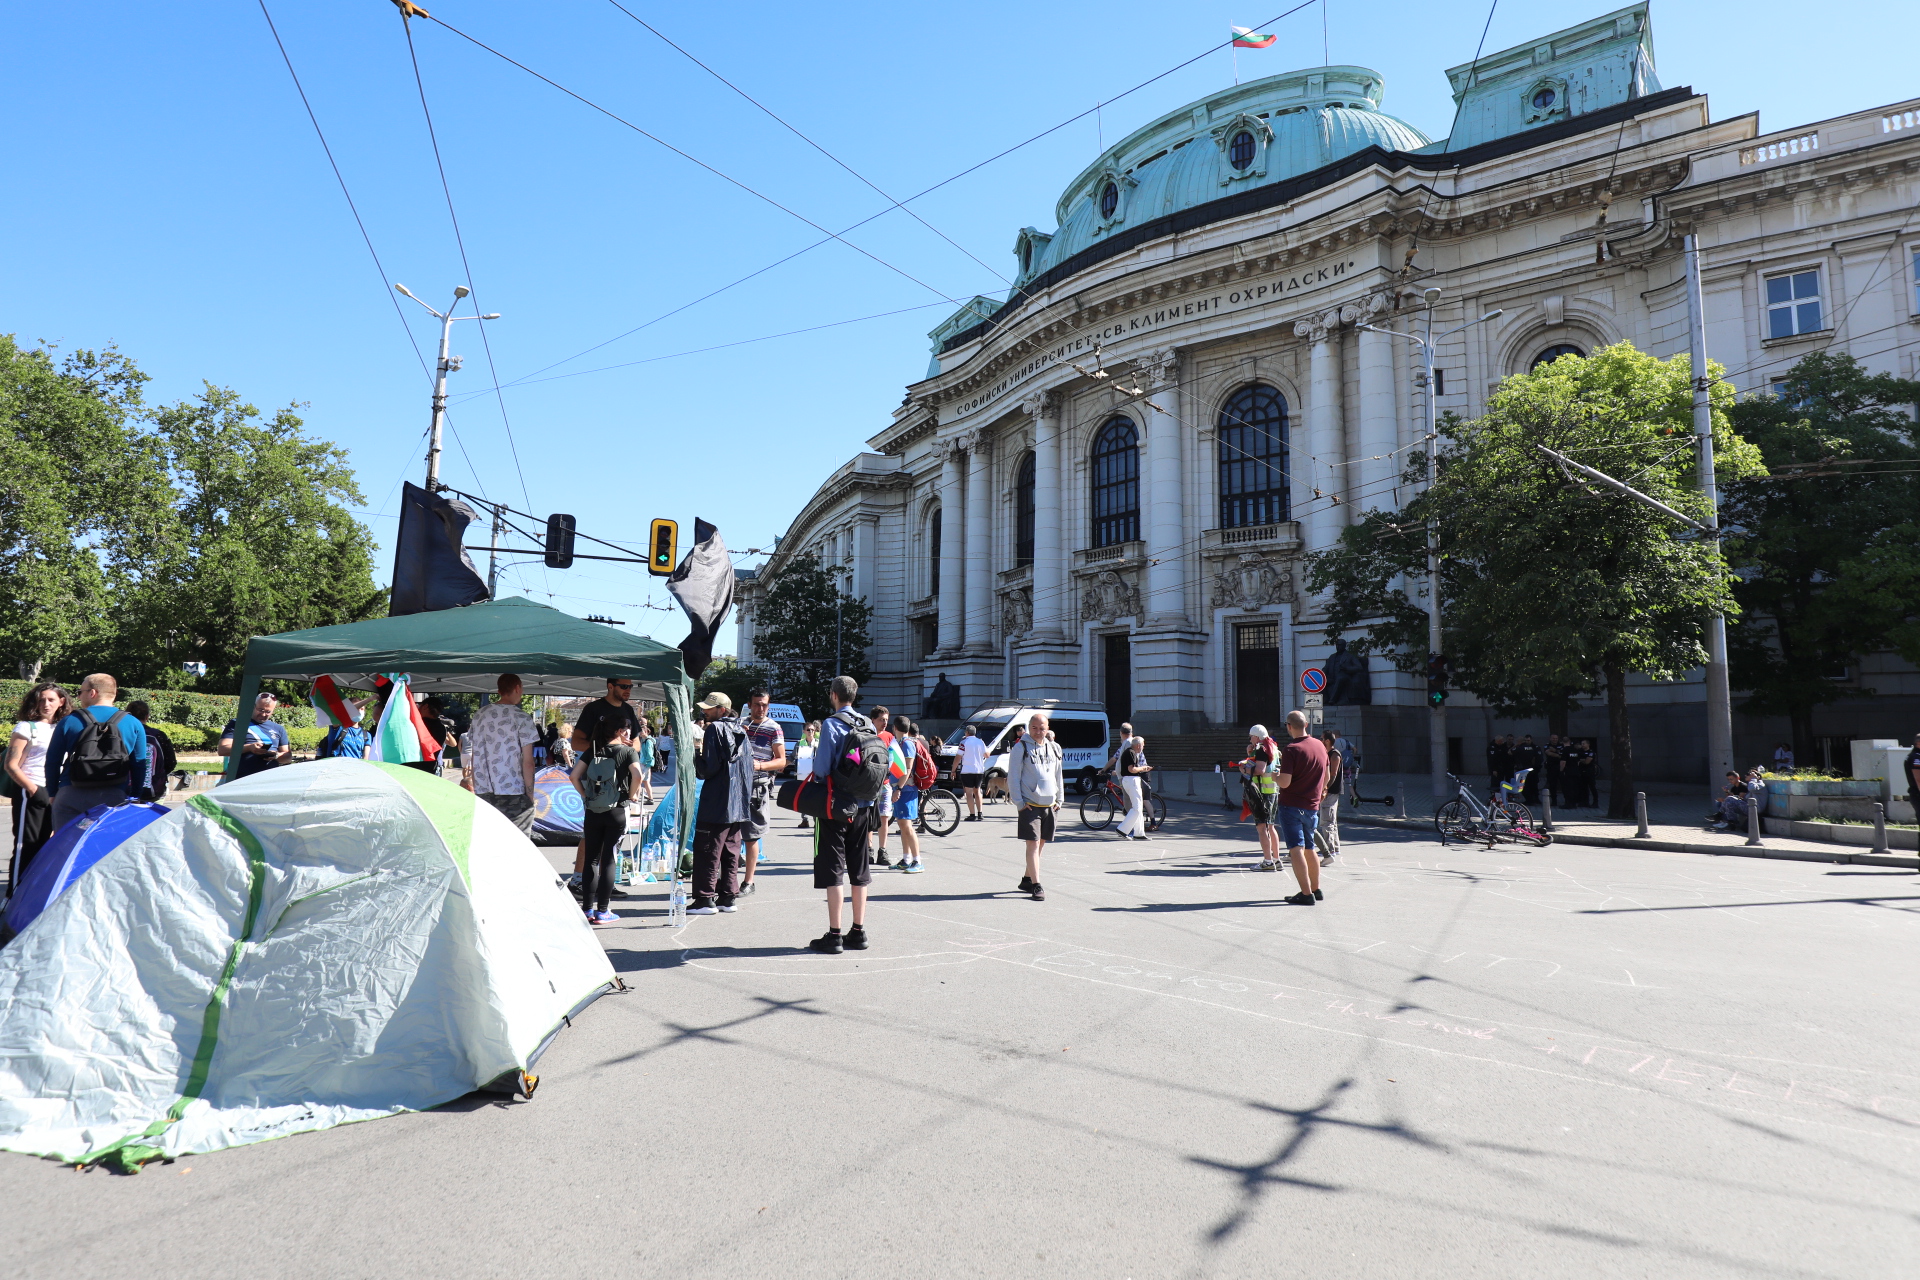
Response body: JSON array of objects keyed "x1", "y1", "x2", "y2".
[{"x1": 0, "y1": 806, "x2": 1920, "y2": 1280}]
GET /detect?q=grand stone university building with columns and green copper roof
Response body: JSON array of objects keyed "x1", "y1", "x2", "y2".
[{"x1": 739, "y1": 4, "x2": 1920, "y2": 777}]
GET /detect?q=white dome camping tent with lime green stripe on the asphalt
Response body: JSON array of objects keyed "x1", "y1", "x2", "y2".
[{"x1": 0, "y1": 760, "x2": 614, "y2": 1169}]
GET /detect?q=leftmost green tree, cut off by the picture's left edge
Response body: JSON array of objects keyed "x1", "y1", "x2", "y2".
[{"x1": 0, "y1": 334, "x2": 156, "y2": 679}]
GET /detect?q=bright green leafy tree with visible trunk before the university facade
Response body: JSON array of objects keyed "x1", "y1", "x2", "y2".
[{"x1": 1308, "y1": 344, "x2": 1759, "y2": 818}]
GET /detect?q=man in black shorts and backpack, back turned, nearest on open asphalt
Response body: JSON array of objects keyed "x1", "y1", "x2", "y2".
[{"x1": 808, "y1": 676, "x2": 889, "y2": 956}]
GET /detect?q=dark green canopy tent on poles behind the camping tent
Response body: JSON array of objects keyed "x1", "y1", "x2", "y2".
[{"x1": 227, "y1": 599, "x2": 693, "y2": 852}]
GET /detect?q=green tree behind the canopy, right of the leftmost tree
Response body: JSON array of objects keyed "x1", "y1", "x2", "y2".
[{"x1": 108, "y1": 384, "x2": 386, "y2": 689}]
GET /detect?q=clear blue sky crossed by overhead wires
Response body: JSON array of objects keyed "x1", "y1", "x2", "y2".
[{"x1": 0, "y1": 0, "x2": 1920, "y2": 649}]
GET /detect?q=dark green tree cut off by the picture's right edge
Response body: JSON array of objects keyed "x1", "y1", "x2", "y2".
[{"x1": 1722, "y1": 351, "x2": 1920, "y2": 760}]
